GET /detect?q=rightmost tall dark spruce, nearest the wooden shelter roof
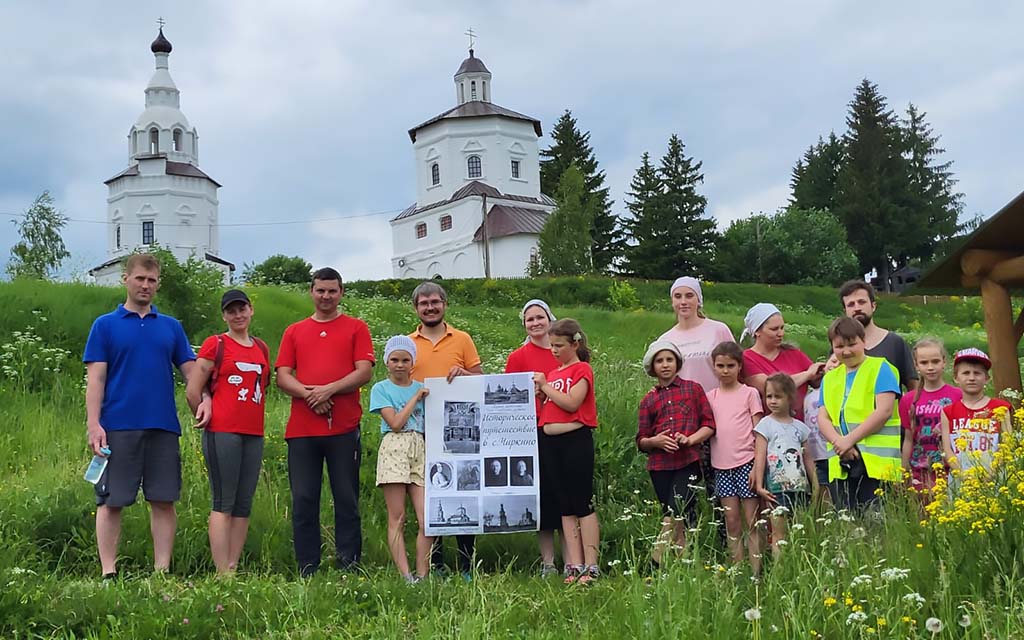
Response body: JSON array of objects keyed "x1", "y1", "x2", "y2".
[{"x1": 897, "y1": 103, "x2": 964, "y2": 265}]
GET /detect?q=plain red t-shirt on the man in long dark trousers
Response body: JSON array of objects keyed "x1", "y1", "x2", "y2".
[{"x1": 273, "y1": 314, "x2": 375, "y2": 438}]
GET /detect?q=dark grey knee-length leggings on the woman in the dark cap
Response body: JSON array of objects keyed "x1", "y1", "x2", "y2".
[{"x1": 203, "y1": 430, "x2": 263, "y2": 518}]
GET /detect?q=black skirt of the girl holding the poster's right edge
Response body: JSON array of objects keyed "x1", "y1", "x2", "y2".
[{"x1": 540, "y1": 427, "x2": 594, "y2": 516}]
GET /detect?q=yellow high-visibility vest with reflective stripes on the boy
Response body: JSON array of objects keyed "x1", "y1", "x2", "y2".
[{"x1": 821, "y1": 355, "x2": 901, "y2": 481}]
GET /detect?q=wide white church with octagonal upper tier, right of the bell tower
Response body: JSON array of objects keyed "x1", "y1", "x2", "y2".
[{"x1": 391, "y1": 49, "x2": 555, "y2": 279}]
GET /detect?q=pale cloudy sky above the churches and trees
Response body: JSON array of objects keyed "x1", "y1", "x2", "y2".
[{"x1": 0, "y1": 0, "x2": 1024, "y2": 280}]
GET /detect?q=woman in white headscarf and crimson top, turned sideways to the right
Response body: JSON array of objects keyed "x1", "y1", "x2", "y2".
[{"x1": 739, "y1": 302, "x2": 825, "y2": 420}]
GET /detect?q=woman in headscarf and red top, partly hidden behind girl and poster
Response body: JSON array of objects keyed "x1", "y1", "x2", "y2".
[{"x1": 505, "y1": 299, "x2": 565, "y2": 578}]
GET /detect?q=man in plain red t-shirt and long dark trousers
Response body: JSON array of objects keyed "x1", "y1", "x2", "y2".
[{"x1": 274, "y1": 267, "x2": 374, "y2": 577}]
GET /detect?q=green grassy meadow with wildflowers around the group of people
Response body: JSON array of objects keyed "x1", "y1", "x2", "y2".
[{"x1": 0, "y1": 279, "x2": 1024, "y2": 639}]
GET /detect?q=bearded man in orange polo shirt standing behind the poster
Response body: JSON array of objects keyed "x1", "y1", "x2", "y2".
[{"x1": 409, "y1": 282, "x2": 483, "y2": 580}]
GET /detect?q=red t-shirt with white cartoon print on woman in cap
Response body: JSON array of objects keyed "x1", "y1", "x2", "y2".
[{"x1": 199, "y1": 336, "x2": 270, "y2": 435}]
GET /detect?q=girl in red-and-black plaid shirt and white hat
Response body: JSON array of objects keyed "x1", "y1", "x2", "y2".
[{"x1": 636, "y1": 340, "x2": 715, "y2": 566}]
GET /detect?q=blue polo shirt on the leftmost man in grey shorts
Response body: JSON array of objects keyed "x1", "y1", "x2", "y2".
[{"x1": 82, "y1": 304, "x2": 196, "y2": 435}]
